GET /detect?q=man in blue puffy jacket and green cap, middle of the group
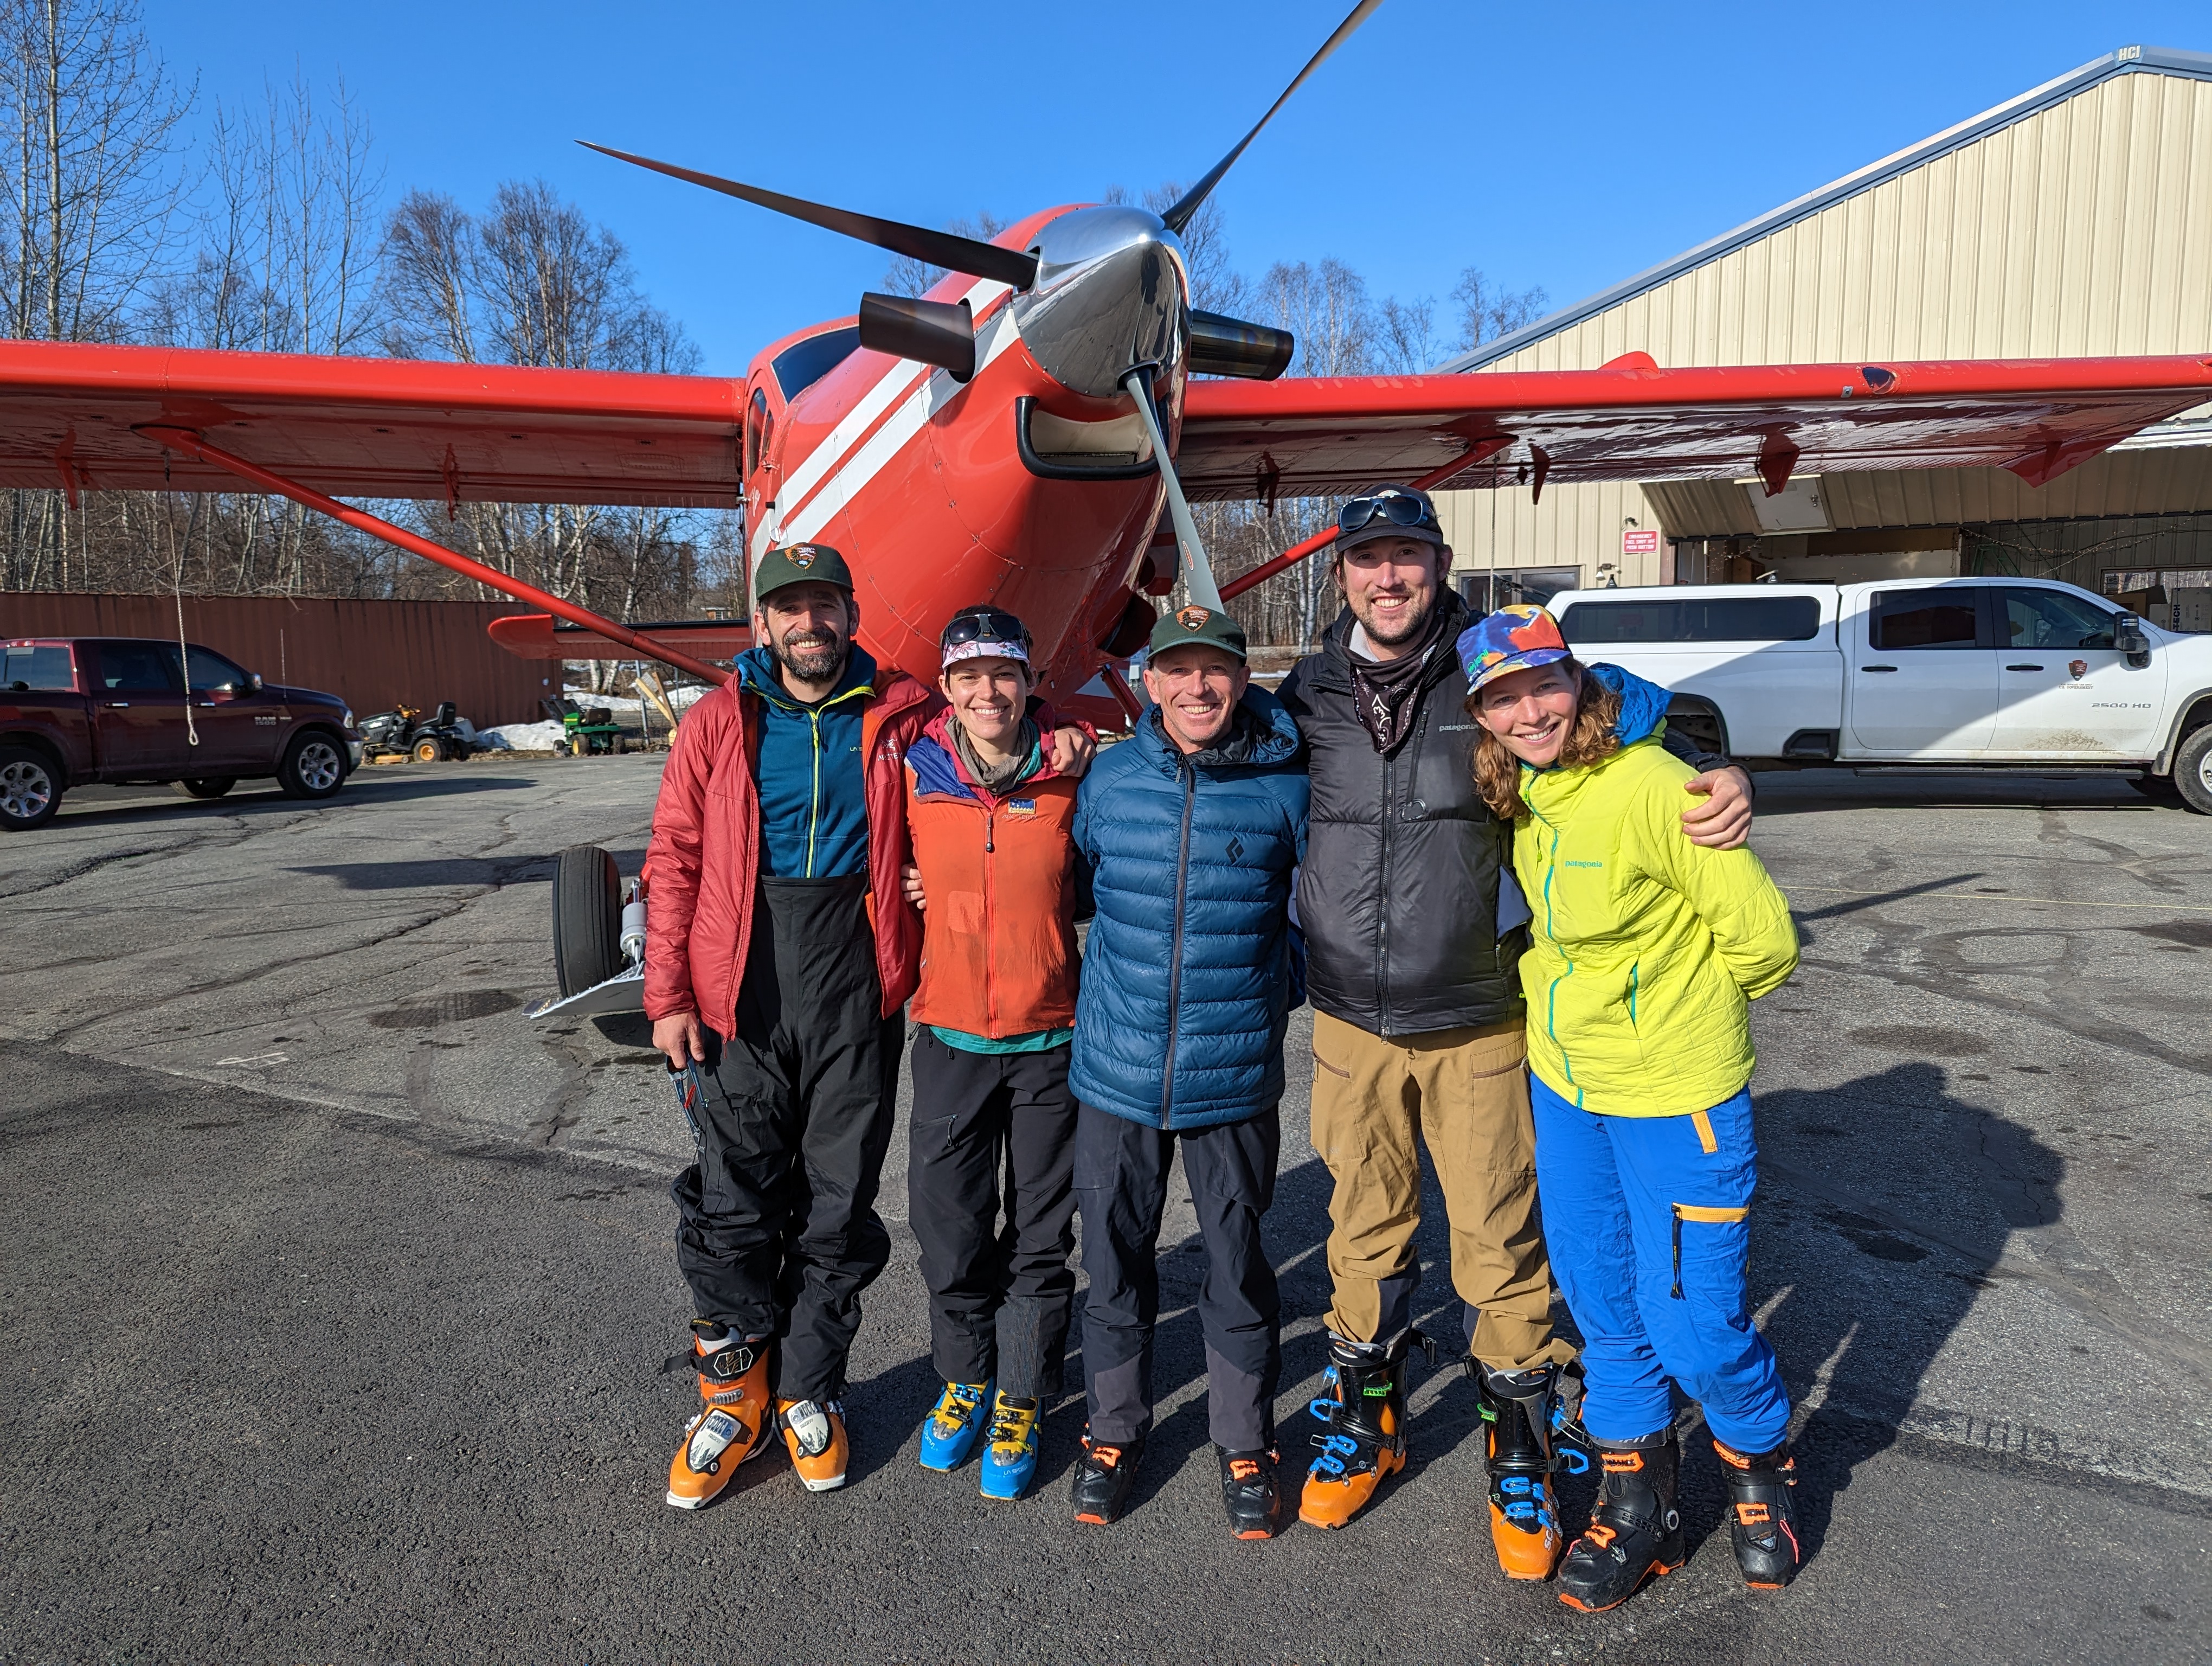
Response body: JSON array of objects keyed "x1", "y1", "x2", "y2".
[{"x1": 1069, "y1": 606, "x2": 1305, "y2": 1537}]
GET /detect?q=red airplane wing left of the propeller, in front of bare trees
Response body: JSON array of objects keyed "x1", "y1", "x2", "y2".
[{"x1": 0, "y1": 341, "x2": 743, "y2": 509}]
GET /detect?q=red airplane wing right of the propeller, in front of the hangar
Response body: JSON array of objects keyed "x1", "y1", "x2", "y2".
[{"x1": 1174, "y1": 354, "x2": 2212, "y2": 502}]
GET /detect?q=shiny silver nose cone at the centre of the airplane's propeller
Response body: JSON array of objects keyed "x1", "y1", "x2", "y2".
[{"x1": 1013, "y1": 208, "x2": 1190, "y2": 396}]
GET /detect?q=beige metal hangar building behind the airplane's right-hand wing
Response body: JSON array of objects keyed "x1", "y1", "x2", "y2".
[{"x1": 1438, "y1": 47, "x2": 2212, "y2": 631}]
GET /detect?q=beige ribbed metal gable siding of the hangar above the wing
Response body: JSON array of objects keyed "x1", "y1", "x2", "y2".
[{"x1": 1487, "y1": 73, "x2": 2212, "y2": 369}]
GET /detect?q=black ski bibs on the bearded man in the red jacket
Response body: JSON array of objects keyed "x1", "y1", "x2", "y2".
[{"x1": 670, "y1": 876, "x2": 905, "y2": 1400}]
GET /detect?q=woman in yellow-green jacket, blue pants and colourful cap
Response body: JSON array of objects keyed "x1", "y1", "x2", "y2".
[{"x1": 1460, "y1": 606, "x2": 1798, "y2": 1611}]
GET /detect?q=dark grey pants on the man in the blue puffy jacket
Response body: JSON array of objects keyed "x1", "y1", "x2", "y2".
[{"x1": 1075, "y1": 1104, "x2": 1283, "y2": 1451}]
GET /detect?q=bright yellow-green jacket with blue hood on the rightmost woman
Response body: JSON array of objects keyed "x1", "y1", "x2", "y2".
[{"x1": 1513, "y1": 666, "x2": 1798, "y2": 1117}]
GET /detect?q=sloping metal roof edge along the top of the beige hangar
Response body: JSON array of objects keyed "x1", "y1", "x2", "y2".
[{"x1": 1438, "y1": 47, "x2": 2212, "y2": 371}]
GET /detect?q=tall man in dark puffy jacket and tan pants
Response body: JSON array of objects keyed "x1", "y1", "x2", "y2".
[{"x1": 1281, "y1": 487, "x2": 1750, "y2": 1580}]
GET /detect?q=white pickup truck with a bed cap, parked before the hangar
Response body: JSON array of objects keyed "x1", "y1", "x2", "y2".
[{"x1": 1551, "y1": 578, "x2": 2212, "y2": 814}]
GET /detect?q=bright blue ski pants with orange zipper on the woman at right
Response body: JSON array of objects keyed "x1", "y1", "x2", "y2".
[{"x1": 1528, "y1": 1075, "x2": 1790, "y2": 1453}]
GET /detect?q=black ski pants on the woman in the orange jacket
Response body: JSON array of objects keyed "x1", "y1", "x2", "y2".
[{"x1": 907, "y1": 1029, "x2": 1075, "y2": 1400}]
